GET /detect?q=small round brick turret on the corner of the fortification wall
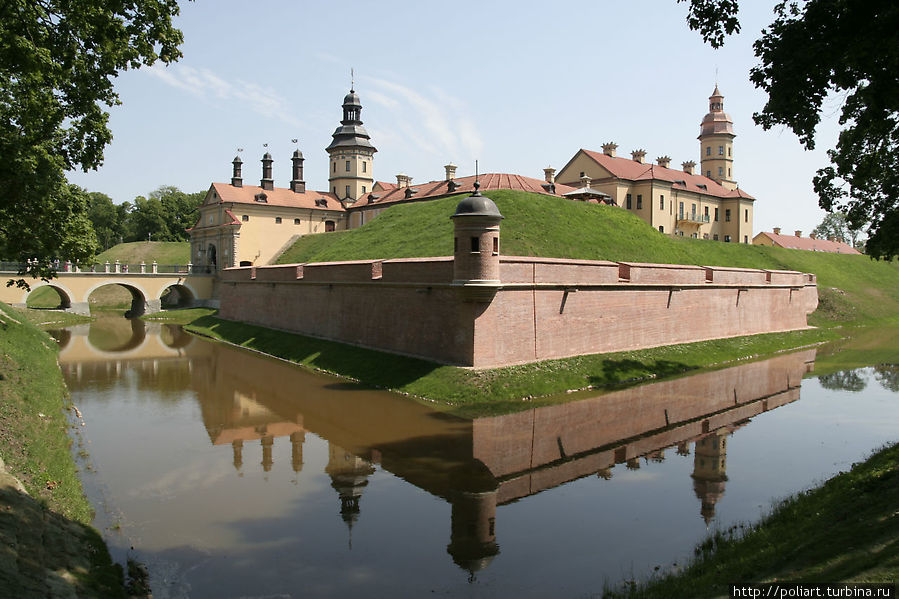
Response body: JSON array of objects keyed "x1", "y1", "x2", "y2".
[{"x1": 450, "y1": 181, "x2": 503, "y2": 302}]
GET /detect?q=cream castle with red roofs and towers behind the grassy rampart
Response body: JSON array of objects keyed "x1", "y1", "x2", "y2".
[{"x1": 189, "y1": 86, "x2": 755, "y2": 271}]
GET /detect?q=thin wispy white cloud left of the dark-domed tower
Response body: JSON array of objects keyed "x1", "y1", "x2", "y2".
[{"x1": 145, "y1": 64, "x2": 301, "y2": 126}]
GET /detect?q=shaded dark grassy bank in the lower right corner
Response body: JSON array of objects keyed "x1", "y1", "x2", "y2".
[{"x1": 604, "y1": 445, "x2": 899, "y2": 598}]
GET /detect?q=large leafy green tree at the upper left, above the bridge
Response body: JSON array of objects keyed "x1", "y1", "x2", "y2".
[{"x1": 0, "y1": 0, "x2": 182, "y2": 284}]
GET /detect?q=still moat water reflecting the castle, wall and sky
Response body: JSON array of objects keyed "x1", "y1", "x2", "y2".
[{"x1": 56, "y1": 318, "x2": 899, "y2": 599}]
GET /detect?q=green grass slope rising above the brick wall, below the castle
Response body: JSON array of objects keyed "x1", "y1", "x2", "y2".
[{"x1": 278, "y1": 190, "x2": 899, "y2": 326}]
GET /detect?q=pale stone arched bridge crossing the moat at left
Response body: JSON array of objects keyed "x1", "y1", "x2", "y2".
[{"x1": 0, "y1": 264, "x2": 217, "y2": 316}]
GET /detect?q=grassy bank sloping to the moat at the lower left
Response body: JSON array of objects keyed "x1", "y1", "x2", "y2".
[{"x1": 0, "y1": 303, "x2": 123, "y2": 597}]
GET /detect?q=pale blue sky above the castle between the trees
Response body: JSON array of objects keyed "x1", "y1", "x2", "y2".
[{"x1": 69, "y1": 0, "x2": 839, "y2": 236}]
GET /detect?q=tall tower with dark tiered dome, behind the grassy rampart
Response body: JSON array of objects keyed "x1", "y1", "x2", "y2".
[{"x1": 325, "y1": 88, "x2": 378, "y2": 204}]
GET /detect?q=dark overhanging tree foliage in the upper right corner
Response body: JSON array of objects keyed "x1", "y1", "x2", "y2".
[{"x1": 678, "y1": 0, "x2": 899, "y2": 259}]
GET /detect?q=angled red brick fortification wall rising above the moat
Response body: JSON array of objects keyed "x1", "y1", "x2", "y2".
[{"x1": 220, "y1": 257, "x2": 818, "y2": 368}]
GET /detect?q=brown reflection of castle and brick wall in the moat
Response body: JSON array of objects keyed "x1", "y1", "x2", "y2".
[{"x1": 54, "y1": 327, "x2": 815, "y2": 575}]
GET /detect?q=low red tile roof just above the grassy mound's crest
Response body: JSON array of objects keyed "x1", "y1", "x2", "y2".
[{"x1": 349, "y1": 173, "x2": 574, "y2": 210}]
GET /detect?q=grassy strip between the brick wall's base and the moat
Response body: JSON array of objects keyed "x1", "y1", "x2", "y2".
[{"x1": 179, "y1": 315, "x2": 836, "y2": 416}]
